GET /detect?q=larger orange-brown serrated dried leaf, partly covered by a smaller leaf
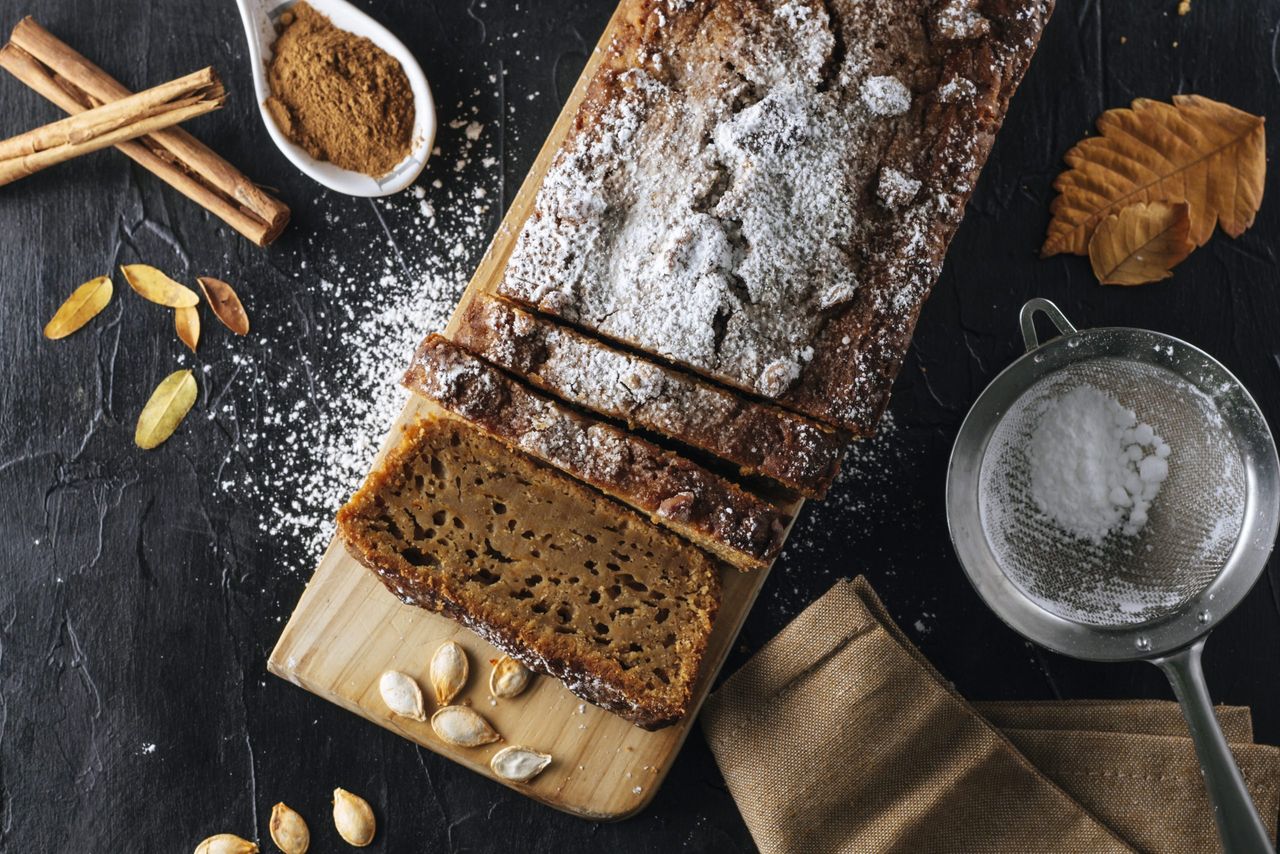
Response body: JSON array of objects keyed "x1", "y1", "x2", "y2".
[{"x1": 1041, "y1": 95, "x2": 1266, "y2": 257}]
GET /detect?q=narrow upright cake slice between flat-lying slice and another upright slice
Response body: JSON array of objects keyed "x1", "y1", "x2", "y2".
[{"x1": 404, "y1": 335, "x2": 790, "y2": 570}]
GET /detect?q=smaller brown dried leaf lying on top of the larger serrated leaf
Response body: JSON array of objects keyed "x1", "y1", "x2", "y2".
[{"x1": 1089, "y1": 201, "x2": 1196, "y2": 284}]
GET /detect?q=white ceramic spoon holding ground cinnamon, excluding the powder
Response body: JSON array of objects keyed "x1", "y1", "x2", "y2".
[{"x1": 236, "y1": 0, "x2": 435, "y2": 196}]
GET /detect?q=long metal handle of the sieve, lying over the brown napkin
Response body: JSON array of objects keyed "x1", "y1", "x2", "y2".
[{"x1": 1151, "y1": 638, "x2": 1275, "y2": 854}]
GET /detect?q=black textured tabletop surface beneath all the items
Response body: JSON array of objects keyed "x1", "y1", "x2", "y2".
[{"x1": 0, "y1": 0, "x2": 1280, "y2": 851}]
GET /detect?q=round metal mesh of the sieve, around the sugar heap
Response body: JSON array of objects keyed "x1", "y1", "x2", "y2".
[{"x1": 978, "y1": 357, "x2": 1247, "y2": 627}]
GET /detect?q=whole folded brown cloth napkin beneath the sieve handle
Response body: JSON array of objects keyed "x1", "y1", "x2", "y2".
[{"x1": 701, "y1": 577, "x2": 1280, "y2": 854}]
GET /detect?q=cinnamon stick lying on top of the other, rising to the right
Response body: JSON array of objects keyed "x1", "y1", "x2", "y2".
[{"x1": 0, "y1": 68, "x2": 227, "y2": 186}]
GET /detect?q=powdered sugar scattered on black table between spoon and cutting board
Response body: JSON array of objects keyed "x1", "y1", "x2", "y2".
[{"x1": 217, "y1": 105, "x2": 499, "y2": 571}]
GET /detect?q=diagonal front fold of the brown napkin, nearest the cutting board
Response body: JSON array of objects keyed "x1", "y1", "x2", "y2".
[{"x1": 701, "y1": 577, "x2": 1130, "y2": 854}]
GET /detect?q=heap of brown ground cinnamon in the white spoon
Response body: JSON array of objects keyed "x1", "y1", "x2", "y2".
[{"x1": 266, "y1": 3, "x2": 413, "y2": 178}]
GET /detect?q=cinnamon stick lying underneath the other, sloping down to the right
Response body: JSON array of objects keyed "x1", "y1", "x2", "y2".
[{"x1": 0, "y1": 18, "x2": 289, "y2": 246}]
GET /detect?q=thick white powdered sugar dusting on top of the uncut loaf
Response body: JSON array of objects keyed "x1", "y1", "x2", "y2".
[{"x1": 503, "y1": 0, "x2": 910, "y2": 396}]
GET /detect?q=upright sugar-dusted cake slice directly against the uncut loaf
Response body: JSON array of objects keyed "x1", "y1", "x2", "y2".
[{"x1": 453, "y1": 293, "x2": 844, "y2": 498}]
